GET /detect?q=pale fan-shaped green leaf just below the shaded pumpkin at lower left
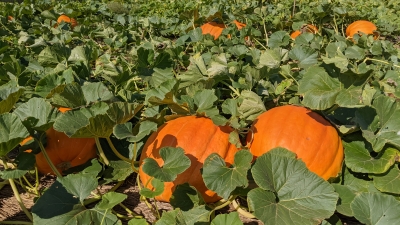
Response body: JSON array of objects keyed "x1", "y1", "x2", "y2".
[{"x1": 58, "y1": 173, "x2": 99, "y2": 202}]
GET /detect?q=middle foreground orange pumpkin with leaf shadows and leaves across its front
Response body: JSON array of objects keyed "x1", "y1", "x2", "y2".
[{"x1": 139, "y1": 116, "x2": 238, "y2": 202}]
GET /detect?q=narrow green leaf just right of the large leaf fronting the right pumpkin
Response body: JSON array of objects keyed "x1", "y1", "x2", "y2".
[{"x1": 332, "y1": 184, "x2": 356, "y2": 217}]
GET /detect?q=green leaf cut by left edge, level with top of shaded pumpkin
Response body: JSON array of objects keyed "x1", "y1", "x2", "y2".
[{"x1": 0, "y1": 113, "x2": 29, "y2": 156}]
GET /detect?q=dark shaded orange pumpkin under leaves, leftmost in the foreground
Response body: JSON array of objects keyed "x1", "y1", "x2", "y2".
[{"x1": 21, "y1": 107, "x2": 97, "y2": 175}]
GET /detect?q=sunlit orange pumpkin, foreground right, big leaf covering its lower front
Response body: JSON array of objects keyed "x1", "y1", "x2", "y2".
[{"x1": 247, "y1": 105, "x2": 344, "y2": 180}]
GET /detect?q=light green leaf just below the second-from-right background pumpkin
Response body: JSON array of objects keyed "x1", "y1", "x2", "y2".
[{"x1": 289, "y1": 45, "x2": 318, "y2": 68}]
